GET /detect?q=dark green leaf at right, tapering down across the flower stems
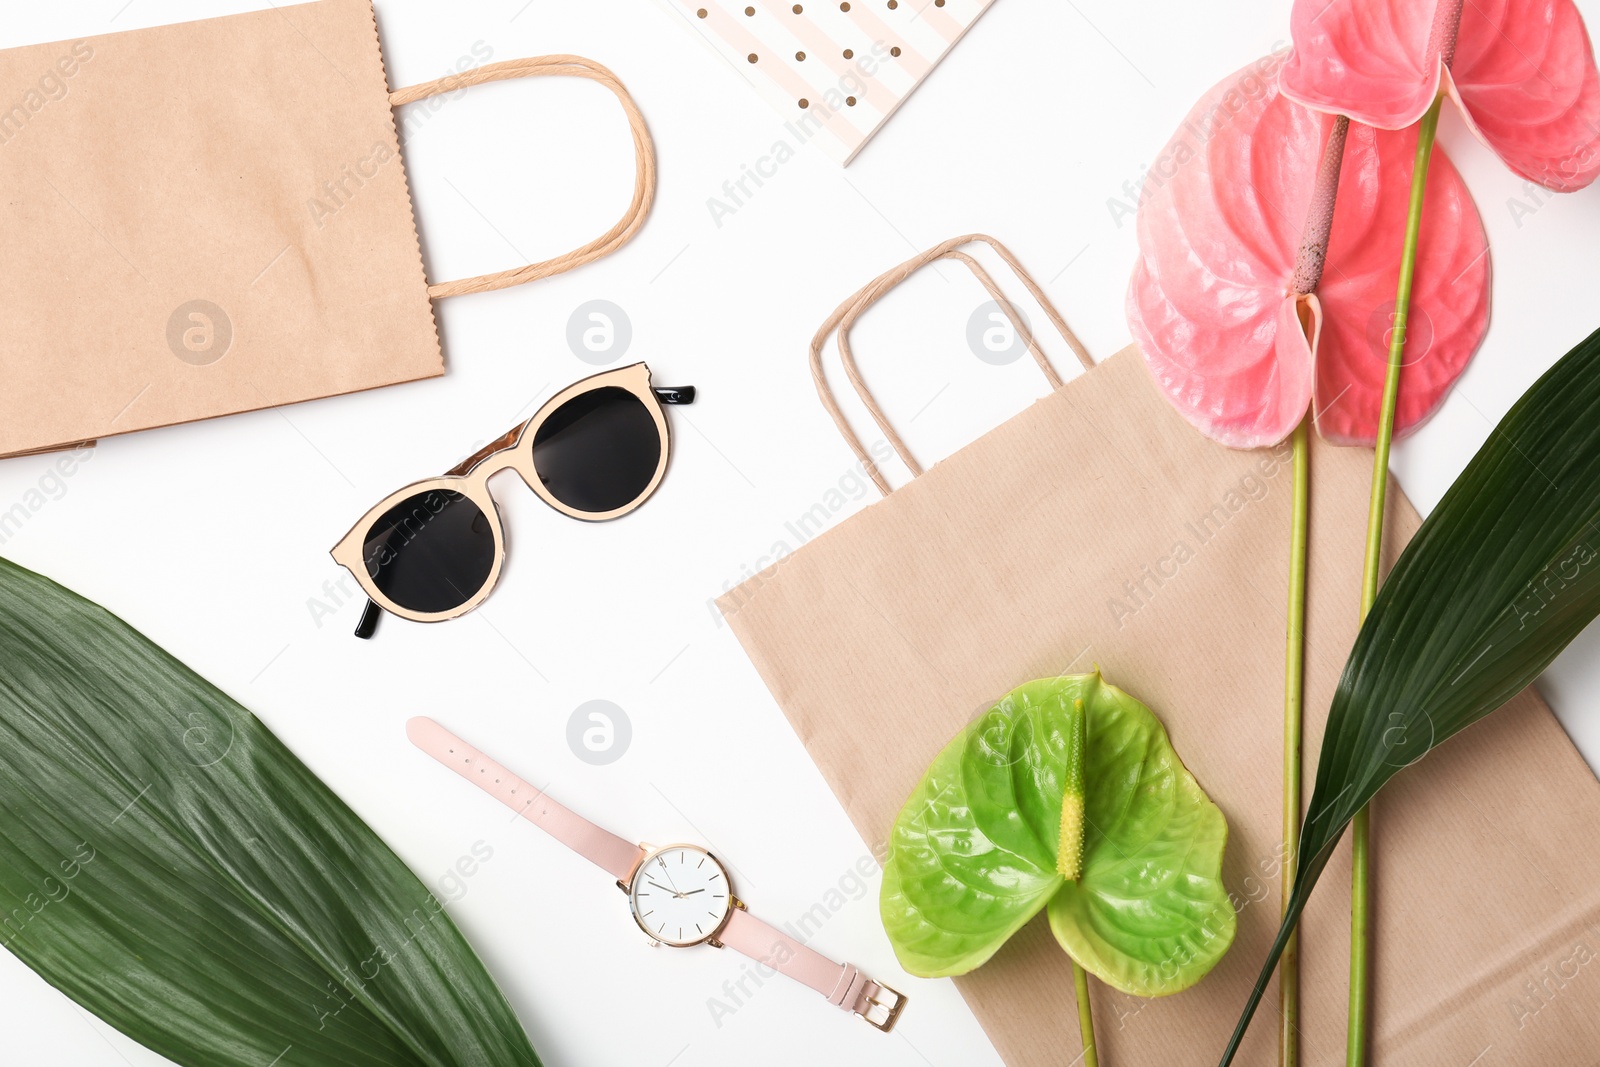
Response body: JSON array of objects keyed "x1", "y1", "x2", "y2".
[{"x1": 1221, "y1": 331, "x2": 1600, "y2": 1067}]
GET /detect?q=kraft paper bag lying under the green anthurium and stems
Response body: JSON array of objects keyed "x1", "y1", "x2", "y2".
[{"x1": 720, "y1": 242, "x2": 1600, "y2": 1067}]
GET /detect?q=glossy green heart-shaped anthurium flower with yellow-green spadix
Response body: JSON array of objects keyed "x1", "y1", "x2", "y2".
[{"x1": 880, "y1": 672, "x2": 1235, "y2": 997}]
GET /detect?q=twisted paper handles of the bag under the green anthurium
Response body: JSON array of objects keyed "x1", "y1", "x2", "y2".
[{"x1": 811, "y1": 234, "x2": 1094, "y2": 496}]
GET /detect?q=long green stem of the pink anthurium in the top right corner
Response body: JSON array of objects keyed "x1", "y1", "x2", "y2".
[{"x1": 1344, "y1": 94, "x2": 1445, "y2": 1067}]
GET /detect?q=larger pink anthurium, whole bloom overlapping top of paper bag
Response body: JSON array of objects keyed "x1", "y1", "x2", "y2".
[{"x1": 1126, "y1": 61, "x2": 1490, "y2": 448}]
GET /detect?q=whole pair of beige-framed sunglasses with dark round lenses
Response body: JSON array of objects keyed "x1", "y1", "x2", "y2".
[{"x1": 331, "y1": 363, "x2": 694, "y2": 638}]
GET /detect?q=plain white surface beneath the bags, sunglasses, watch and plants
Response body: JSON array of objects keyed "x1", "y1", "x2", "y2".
[{"x1": 0, "y1": 0, "x2": 1600, "y2": 1067}]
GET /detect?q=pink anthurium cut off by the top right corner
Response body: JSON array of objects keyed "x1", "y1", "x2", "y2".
[{"x1": 1282, "y1": 0, "x2": 1600, "y2": 192}]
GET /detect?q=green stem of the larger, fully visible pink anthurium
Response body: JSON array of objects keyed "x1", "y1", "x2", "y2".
[{"x1": 1278, "y1": 416, "x2": 1310, "y2": 1067}]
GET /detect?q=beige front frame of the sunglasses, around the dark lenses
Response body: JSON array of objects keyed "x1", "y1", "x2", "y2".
[{"x1": 330, "y1": 363, "x2": 678, "y2": 622}]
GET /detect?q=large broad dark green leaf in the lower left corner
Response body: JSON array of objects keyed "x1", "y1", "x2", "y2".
[{"x1": 0, "y1": 560, "x2": 539, "y2": 1067}]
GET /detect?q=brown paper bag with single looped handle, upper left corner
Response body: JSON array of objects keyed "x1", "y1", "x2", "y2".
[{"x1": 0, "y1": 0, "x2": 654, "y2": 456}]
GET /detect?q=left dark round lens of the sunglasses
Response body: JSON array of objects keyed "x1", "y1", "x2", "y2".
[{"x1": 362, "y1": 490, "x2": 494, "y2": 613}]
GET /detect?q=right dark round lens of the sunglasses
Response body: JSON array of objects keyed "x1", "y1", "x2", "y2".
[{"x1": 533, "y1": 386, "x2": 662, "y2": 514}]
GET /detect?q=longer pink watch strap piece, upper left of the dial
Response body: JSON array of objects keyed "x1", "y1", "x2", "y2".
[{"x1": 405, "y1": 717, "x2": 645, "y2": 881}]
